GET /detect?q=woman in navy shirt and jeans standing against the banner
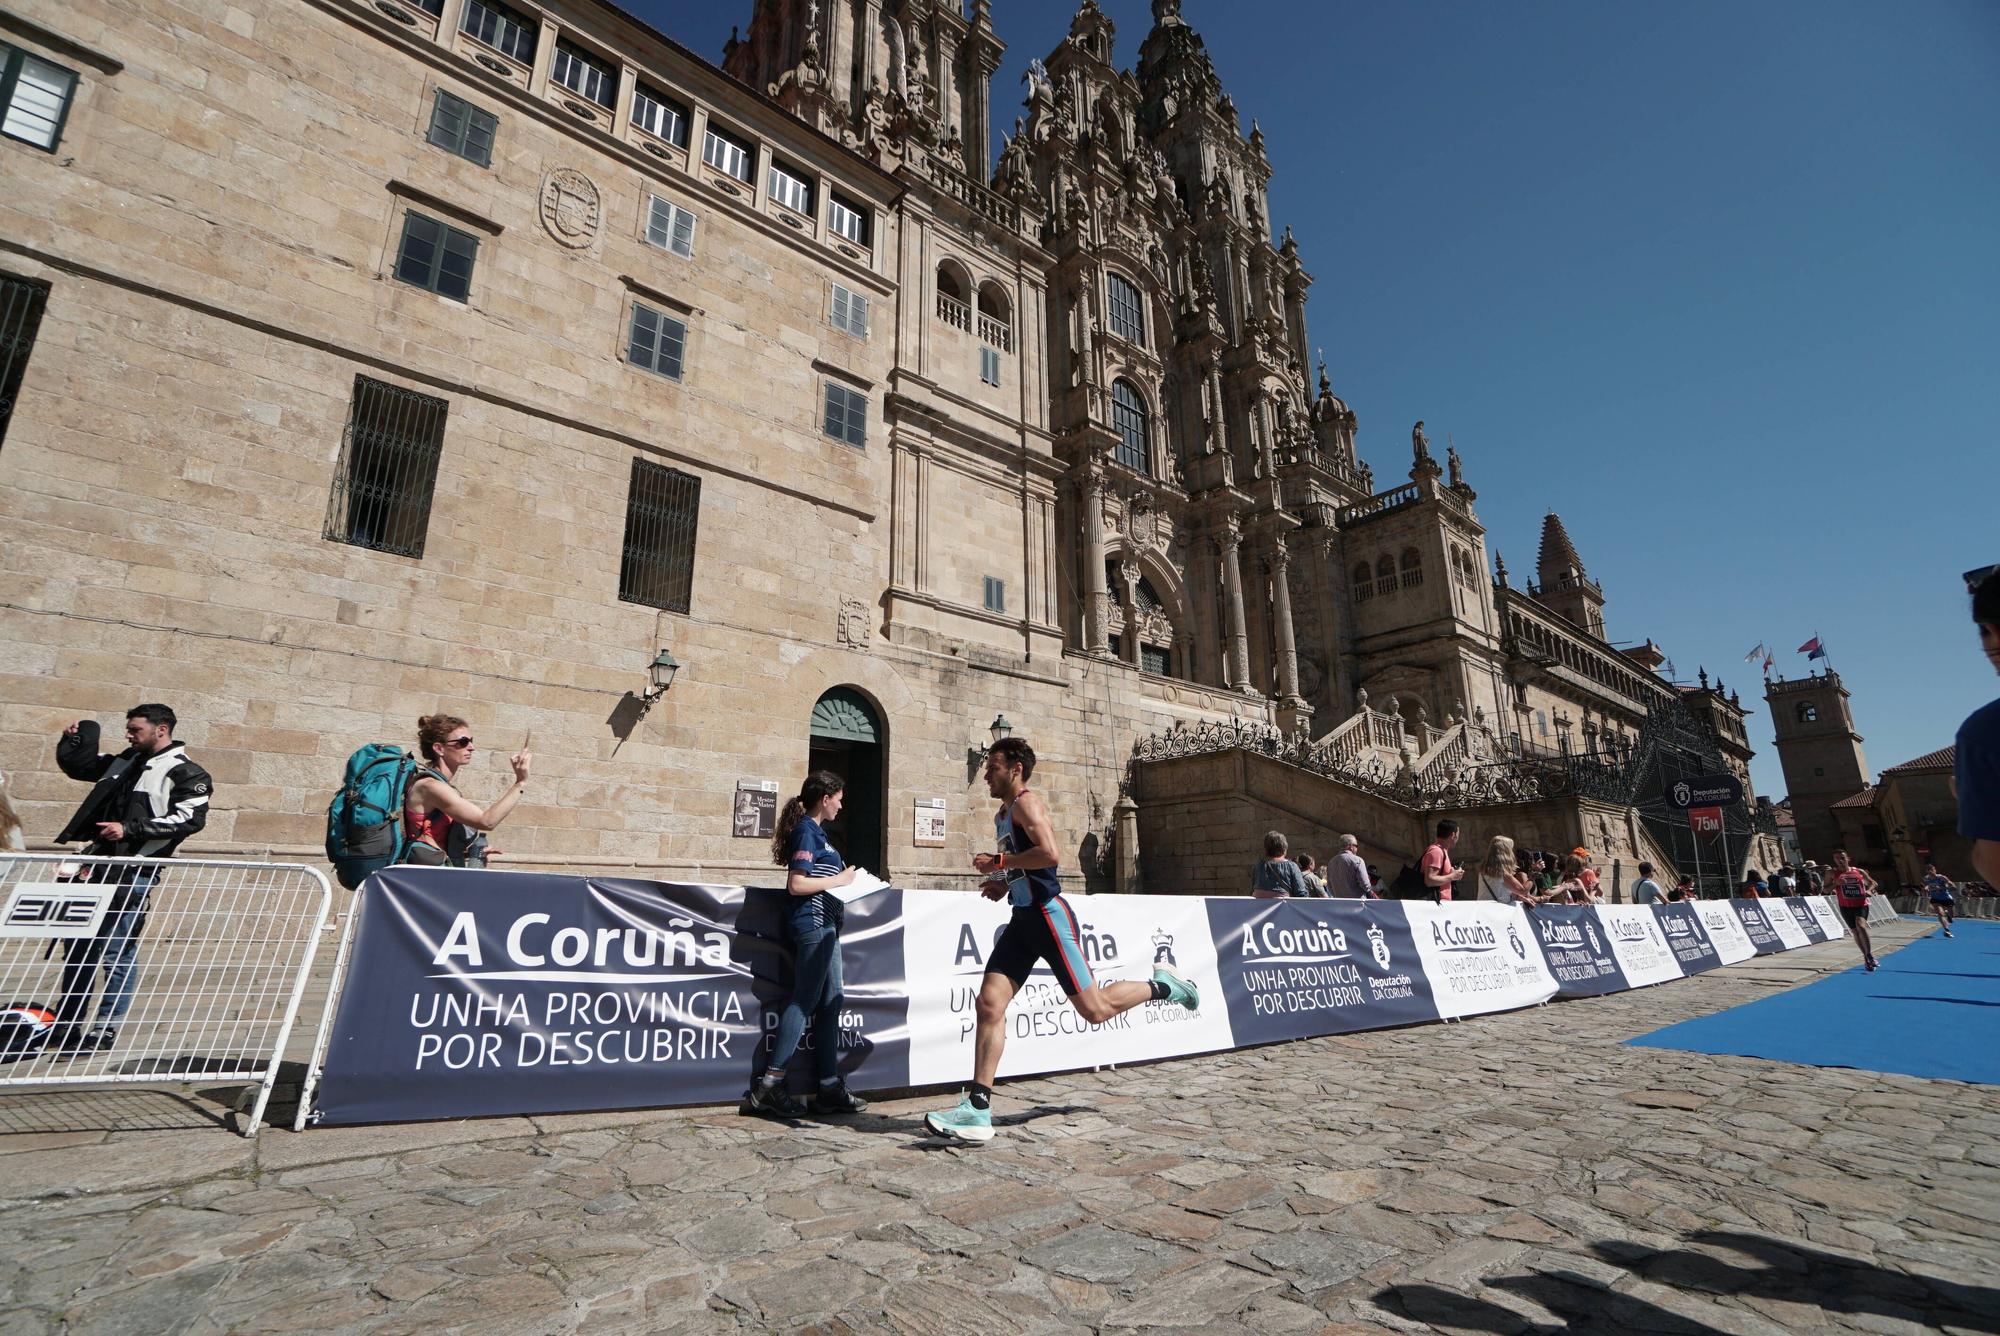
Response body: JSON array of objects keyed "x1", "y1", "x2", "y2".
[{"x1": 742, "y1": 770, "x2": 868, "y2": 1118}]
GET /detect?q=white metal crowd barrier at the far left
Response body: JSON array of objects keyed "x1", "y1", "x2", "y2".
[{"x1": 0, "y1": 854, "x2": 332, "y2": 1136}]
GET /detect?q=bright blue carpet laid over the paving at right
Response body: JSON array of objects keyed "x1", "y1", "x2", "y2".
[{"x1": 1626, "y1": 922, "x2": 2000, "y2": 1086}]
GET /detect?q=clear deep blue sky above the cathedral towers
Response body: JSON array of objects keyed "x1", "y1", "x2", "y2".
[{"x1": 626, "y1": 0, "x2": 2000, "y2": 796}]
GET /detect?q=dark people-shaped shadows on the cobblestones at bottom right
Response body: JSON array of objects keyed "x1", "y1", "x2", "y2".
[{"x1": 1374, "y1": 1230, "x2": 2000, "y2": 1336}]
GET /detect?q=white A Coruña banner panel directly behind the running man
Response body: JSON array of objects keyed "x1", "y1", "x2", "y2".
[{"x1": 902, "y1": 890, "x2": 1234, "y2": 1086}]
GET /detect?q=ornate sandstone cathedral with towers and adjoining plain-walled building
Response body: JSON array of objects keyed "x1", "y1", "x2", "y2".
[{"x1": 0, "y1": 0, "x2": 1758, "y2": 890}]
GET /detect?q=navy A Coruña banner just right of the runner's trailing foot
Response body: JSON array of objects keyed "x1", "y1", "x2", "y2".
[{"x1": 1206, "y1": 898, "x2": 1438, "y2": 1046}]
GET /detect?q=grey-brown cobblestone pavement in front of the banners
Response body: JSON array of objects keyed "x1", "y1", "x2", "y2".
[{"x1": 0, "y1": 924, "x2": 2000, "y2": 1336}]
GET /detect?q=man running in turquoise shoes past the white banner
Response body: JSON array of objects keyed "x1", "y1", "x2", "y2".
[{"x1": 924, "y1": 738, "x2": 1202, "y2": 1142}]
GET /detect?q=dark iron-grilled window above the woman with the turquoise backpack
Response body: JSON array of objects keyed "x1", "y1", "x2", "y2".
[{"x1": 326, "y1": 376, "x2": 446, "y2": 556}]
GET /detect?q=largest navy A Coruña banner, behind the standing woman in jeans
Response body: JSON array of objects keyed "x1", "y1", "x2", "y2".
[{"x1": 318, "y1": 868, "x2": 908, "y2": 1124}]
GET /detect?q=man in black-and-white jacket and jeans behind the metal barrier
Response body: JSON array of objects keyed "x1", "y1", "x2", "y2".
[{"x1": 48, "y1": 704, "x2": 214, "y2": 1054}]
